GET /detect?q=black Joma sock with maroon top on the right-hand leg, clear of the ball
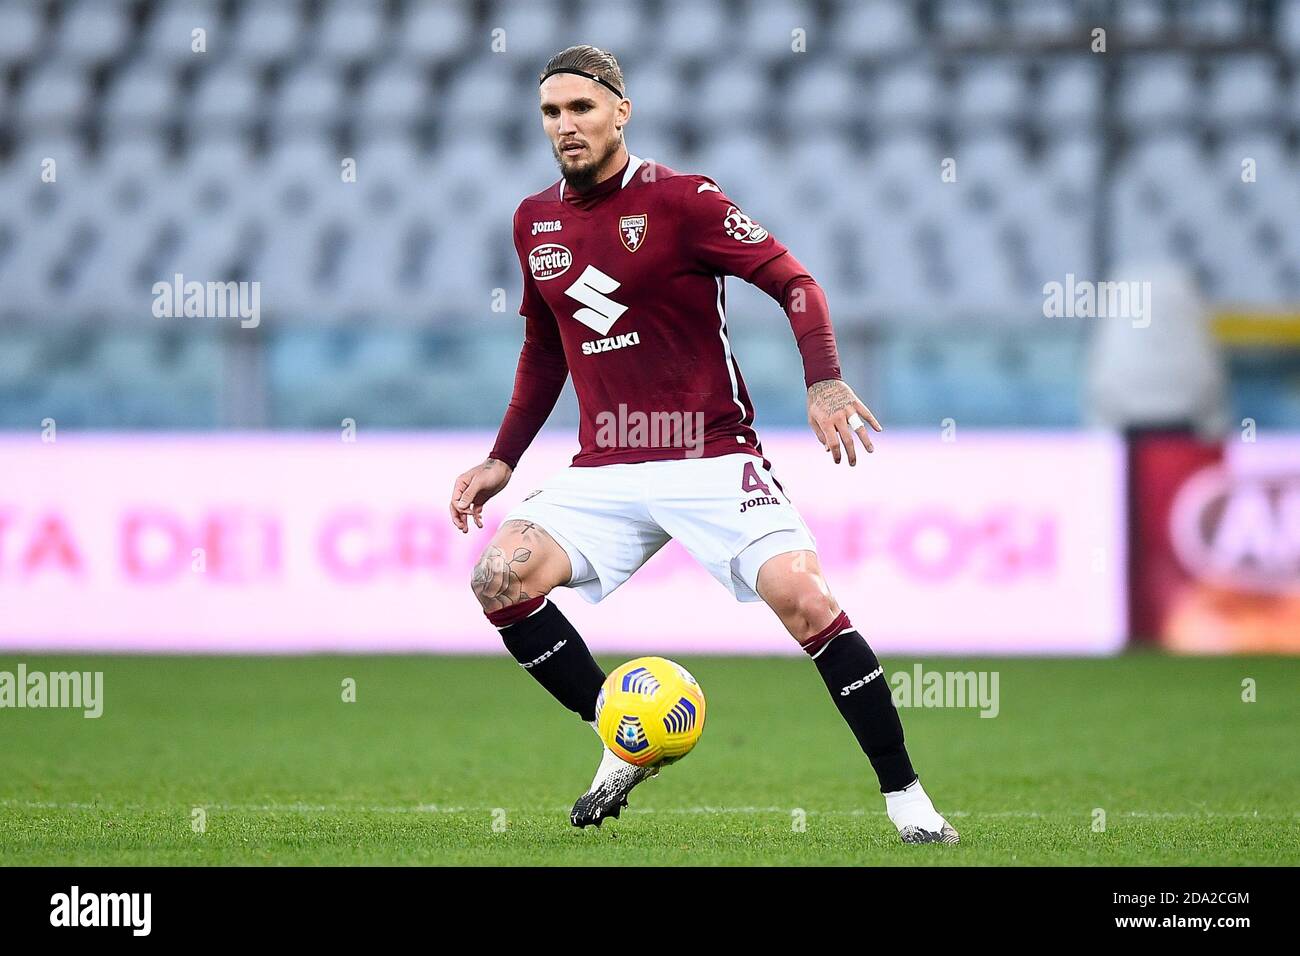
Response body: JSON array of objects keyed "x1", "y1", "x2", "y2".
[{"x1": 801, "y1": 611, "x2": 917, "y2": 793}]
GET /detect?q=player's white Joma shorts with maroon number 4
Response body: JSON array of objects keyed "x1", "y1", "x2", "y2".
[{"x1": 504, "y1": 453, "x2": 816, "y2": 604}]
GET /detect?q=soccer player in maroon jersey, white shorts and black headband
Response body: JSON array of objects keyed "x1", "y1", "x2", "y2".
[{"x1": 449, "y1": 46, "x2": 958, "y2": 843}]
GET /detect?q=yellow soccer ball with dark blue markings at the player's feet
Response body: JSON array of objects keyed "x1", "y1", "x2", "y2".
[{"x1": 595, "y1": 657, "x2": 705, "y2": 767}]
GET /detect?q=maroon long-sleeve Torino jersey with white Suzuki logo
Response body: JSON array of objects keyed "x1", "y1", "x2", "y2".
[{"x1": 491, "y1": 156, "x2": 840, "y2": 467}]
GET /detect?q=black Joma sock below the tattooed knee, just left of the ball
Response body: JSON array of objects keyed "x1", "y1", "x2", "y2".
[{"x1": 488, "y1": 596, "x2": 605, "y2": 721}]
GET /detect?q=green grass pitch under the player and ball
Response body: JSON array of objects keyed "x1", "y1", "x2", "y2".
[{"x1": 0, "y1": 653, "x2": 1300, "y2": 866}]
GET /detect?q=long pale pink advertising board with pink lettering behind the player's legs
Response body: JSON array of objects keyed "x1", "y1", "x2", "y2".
[{"x1": 0, "y1": 429, "x2": 1126, "y2": 654}]
